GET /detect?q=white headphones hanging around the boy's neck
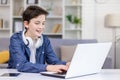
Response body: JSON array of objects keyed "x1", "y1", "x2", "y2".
[{"x1": 22, "y1": 31, "x2": 43, "y2": 48}]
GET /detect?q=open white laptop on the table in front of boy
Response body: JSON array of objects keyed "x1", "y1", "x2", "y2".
[{"x1": 40, "y1": 42, "x2": 112, "y2": 78}]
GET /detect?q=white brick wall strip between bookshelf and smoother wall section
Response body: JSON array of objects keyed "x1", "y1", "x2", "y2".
[{"x1": 82, "y1": 0, "x2": 95, "y2": 39}]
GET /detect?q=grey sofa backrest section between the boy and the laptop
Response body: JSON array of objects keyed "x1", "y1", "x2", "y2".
[{"x1": 50, "y1": 38, "x2": 97, "y2": 59}]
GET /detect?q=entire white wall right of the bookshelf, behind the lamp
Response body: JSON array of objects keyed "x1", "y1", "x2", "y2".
[{"x1": 82, "y1": 0, "x2": 120, "y2": 68}]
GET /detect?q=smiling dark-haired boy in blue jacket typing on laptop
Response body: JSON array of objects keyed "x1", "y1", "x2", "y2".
[{"x1": 8, "y1": 6, "x2": 70, "y2": 73}]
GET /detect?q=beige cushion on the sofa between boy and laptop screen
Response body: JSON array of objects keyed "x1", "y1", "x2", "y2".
[{"x1": 60, "y1": 45, "x2": 76, "y2": 62}]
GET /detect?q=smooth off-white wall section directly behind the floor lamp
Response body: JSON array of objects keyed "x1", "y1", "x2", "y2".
[{"x1": 95, "y1": 0, "x2": 120, "y2": 68}]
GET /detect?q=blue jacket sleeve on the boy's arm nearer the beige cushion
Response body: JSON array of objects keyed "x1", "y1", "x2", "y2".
[{"x1": 45, "y1": 38, "x2": 66, "y2": 65}]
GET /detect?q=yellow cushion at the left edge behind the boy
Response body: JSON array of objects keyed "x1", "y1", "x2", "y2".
[{"x1": 0, "y1": 50, "x2": 9, "y2": 64}]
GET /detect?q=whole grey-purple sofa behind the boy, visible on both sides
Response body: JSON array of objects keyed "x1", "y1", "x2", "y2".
[{"x1": 0, "y1": 38, "x2": 113, "y2": 69}]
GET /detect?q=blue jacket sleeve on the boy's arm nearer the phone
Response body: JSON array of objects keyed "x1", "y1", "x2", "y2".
[{"x1": 10, "y1": 35, "x2": 47, "y2": 73}]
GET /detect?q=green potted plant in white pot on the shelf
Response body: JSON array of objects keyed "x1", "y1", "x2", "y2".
[{"x1": 66, "y1": 14, "x2": 81, "y2": 28}]
